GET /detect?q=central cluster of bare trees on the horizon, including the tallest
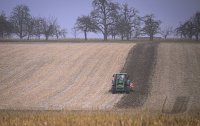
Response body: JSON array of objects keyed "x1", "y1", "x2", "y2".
[{"x1": 75, "y1": 0, "x2": 161, "y2": 40}]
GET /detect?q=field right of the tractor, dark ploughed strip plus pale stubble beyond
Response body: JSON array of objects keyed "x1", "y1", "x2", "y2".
[{"x1": 117, "y1": 43, "x2": 200, "y2": 113}]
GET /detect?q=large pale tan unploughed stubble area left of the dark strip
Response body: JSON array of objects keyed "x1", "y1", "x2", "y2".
[{"x1": 0, "y1": 43, "x2": 134, "y2": 109}]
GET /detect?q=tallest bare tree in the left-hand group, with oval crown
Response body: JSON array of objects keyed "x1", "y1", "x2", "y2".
[{"x1": 10, "y1": 5, "x2": 31, "y2": 39}]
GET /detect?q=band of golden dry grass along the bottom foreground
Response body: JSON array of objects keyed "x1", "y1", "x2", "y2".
[{"x1": 0, "y1": 111, "x2": 200, "y2": 126}]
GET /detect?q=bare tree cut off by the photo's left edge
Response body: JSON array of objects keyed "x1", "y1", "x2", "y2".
[{"x1": 0, "y1": 12, "x2": 12, "y2": 38}]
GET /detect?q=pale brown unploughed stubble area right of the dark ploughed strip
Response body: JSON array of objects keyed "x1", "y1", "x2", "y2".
[{"x1": 144, "y1": 43, "x2": 200, "y2": 113}]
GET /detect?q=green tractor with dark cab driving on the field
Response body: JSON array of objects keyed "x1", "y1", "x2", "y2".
[{"x1": 112, "y1": 73, "x2": 131, "y2": 94}]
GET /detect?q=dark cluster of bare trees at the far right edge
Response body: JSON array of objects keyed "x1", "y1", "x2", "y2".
[{"x1": 176, "y1": 12, "x2": 200, "y2": 41}]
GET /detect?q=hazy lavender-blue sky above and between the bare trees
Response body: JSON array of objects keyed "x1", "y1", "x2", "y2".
[{"x1": 0, "y1": 0, "x2": 200, "y2": 38}]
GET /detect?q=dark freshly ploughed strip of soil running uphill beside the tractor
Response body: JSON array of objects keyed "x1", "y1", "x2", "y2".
[{"x1": 116, "y1": 42, "x2": 158, "y2": 108}]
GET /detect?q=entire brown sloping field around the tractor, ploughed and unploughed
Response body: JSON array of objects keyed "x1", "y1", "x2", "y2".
[{"x1": 0, "y1": 42, "x2": 200, "y2": 113}]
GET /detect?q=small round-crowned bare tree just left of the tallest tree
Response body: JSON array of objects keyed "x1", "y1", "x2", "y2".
[{"x1": 76, "y1": 16, "x2": 95, "y2": 40}]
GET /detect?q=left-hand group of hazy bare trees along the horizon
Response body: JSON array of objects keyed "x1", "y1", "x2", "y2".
[{"x1": 0, "y1": 5, "x2": 67, "y2": 40}]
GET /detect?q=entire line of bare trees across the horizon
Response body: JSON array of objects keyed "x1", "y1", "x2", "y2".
[{"x1": 0, "y1": 0, "x2": 200, "y2": 40}]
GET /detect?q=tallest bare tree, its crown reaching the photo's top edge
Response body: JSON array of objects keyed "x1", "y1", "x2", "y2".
[{"x1": 91, "y1": 0, "x2": 118, "y2": 40}]
